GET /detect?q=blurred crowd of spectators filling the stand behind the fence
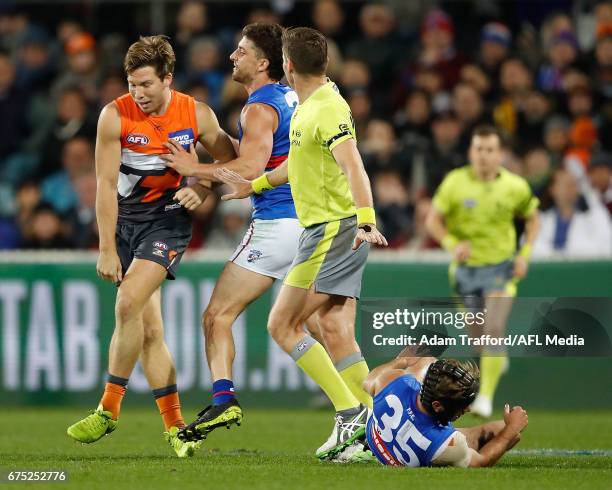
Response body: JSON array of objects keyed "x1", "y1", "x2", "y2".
[{"x1": 0, "y1": 0, "x2": 612, "y2": 256}]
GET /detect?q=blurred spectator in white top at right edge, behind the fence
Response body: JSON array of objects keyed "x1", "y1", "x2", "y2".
[{"x1": 533, "y1": 158, "x2": 612, "y2": 258}]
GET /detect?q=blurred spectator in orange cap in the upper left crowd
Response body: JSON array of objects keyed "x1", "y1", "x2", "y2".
[{"x1": 51, "y1": 32, "x2": 101, "y2": 104}]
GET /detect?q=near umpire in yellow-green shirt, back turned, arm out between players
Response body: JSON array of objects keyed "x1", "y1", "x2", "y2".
[{"x1": 215, "y1": 27, "x2": 387, "y2": 459}]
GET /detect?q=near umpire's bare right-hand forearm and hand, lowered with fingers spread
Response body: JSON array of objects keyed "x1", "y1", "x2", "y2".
[{"x1": 332, "y1": 138, "x2": 388, "y2": 250}]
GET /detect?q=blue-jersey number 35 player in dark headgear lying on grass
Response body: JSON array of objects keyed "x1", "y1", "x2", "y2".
[{"x1": 337, "y1": 357, "x2": 528, "y2": 468}]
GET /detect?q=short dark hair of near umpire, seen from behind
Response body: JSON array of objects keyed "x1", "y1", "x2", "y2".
[{"x1": 283, "y1": 27, "x2": 327, "y2": 75}]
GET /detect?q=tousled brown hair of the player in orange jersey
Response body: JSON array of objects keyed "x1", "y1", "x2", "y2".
[{"x1": 123, "y1": 35, "x2": 176, "y2": 79}]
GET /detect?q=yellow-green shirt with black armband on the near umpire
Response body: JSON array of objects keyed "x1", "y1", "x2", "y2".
[{"x1": 289, "y1": 82, "x2": 357, "y2": 228}]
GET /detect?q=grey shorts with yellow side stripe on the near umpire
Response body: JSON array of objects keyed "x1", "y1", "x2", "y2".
[{"x1": 284, "y1": 216, "x2": 370, "y2": 298}]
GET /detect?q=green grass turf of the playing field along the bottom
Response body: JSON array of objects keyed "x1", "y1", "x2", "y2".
[{"x1": 0, "y1": 407, "x2": 612, "y2": 490}]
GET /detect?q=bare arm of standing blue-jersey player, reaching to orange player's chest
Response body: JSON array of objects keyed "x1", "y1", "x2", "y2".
[{"x1": 162, "y1": 104, "x2": 278, "y2": 180}]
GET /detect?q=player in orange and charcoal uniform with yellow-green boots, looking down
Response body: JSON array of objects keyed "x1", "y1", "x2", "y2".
[{"x1": 68, "y1": 36, "x2": 235, "y2": 457}]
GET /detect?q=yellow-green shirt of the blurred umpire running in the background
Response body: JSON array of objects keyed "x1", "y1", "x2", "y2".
[{"x1": 433, "y1": 165, "x2": 539, "y2": 266}]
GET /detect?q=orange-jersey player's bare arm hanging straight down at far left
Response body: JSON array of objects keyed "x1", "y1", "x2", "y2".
[{"x1": 96, "y1": 103, "x2": 122, "y2": 282}]
